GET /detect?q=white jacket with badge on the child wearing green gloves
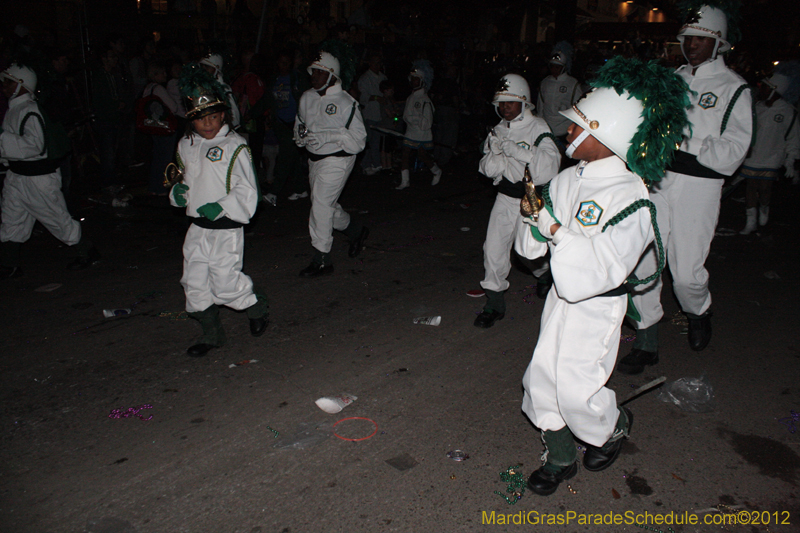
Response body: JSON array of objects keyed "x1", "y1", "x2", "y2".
[{"x1": 169, "y1": 124, "x2": 259, "y2": 224}]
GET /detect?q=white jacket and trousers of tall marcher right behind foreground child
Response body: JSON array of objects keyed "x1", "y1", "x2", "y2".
[{"x1": 633, "y1": 57, "x2": 753, "y2": 329}]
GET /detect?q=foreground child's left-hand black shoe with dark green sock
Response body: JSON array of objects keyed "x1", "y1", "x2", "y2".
[{"x1": 528, "y1": 426, "x2": 578, "y2": 496}]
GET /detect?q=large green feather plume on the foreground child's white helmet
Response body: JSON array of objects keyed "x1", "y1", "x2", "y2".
[{"x1": 591, "y1": 56, "x2": 691, "y2": 185}]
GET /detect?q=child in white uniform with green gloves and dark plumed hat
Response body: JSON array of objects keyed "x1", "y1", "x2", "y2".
[{"x1": 170, "y1": 64, "x2": 269, "y2": 357}]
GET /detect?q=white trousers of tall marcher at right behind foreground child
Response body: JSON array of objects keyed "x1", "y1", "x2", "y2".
[{"x1": 633, "y1": 172, "x2": 723, "y2": 329}]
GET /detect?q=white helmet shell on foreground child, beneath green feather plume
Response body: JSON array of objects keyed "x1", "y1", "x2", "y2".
[{"x1": 559, "y1": 87, "x2": 644, "y2": 163}]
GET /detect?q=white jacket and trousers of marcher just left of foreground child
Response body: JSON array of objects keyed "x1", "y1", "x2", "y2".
[{"x1": 479, "y1": 108, "x2": 561, "y2": 292}]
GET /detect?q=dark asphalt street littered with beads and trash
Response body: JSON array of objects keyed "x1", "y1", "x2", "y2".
[{"x1": 0, "y1": 159, "x2": 800, "y2": 533}]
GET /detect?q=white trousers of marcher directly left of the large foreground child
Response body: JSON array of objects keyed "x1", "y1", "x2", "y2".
[{"x1": 481, "y1": 193, "x2": 522, "y2": 292}]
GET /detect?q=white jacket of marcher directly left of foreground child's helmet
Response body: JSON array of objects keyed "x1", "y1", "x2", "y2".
[{"x1": 478, "y1": 110, "x2": 561, "y2": 185}]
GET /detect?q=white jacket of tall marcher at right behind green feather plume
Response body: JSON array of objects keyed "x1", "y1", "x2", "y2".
[{"x1": 677, "y1": 57, "x2": 753, "y2": 176}]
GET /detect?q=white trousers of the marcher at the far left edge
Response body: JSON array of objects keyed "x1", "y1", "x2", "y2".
[{"x1": 0, "y1": 171, "x2": 81, "y2": 246}]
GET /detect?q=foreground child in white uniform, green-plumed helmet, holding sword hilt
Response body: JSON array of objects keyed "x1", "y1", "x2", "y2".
[{"x1": 516, "y1": 57, "x2": 688, "y2": 495}]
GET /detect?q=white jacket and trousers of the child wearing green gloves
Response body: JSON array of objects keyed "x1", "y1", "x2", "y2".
[{"x1": 169, "y1": 124, "x2": 259, "y2": 313}]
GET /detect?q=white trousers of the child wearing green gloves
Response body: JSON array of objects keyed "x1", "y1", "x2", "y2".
[{"x1": 181, "y1": 224, "x2": 257, "y2": 313}]
